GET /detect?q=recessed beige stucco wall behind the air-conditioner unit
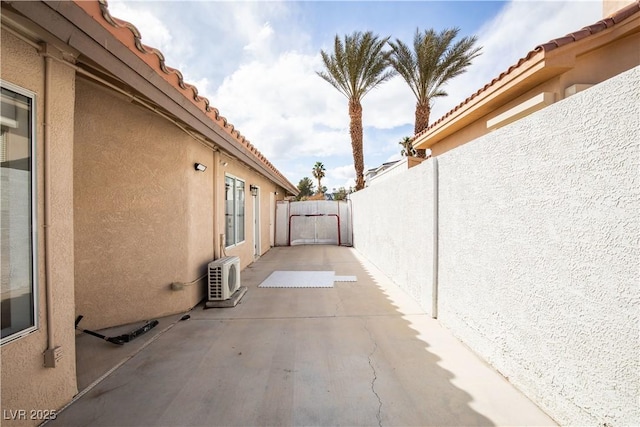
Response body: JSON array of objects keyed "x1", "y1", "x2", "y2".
[{"x1": 74, "y1": 79, "x2": 214, "y2": 329}]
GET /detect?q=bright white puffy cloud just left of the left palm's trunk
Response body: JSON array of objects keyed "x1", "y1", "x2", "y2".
[{"x1": 214, "y1": 51, "x2": 351, "y2": 163}]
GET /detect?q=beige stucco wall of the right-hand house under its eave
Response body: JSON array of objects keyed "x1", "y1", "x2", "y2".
[{"x1": 422, "y1": 20, "x2": 640, "y2": 156}]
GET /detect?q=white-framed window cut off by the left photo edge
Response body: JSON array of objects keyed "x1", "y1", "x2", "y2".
[{"x1": 0, "y1": 81, "x2": 37, "y2": 344}]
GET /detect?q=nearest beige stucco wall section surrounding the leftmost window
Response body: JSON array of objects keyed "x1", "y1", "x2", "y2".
[{"x1": 0, "y1": 30, "x2": 77, "y2": 426}]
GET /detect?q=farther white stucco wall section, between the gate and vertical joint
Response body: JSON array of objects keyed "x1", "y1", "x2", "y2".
[{"x1": 351, "y1": 161, "x2": 433, "y2": 313}]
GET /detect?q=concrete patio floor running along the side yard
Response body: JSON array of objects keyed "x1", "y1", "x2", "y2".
[{"x1": 48, "y1": 246, "x2": 555, "y2": 426}]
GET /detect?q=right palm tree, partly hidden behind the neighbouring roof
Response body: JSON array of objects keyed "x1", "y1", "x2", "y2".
[{"x1": 389, "y1": 28, "x2": 482, "y2": 151}]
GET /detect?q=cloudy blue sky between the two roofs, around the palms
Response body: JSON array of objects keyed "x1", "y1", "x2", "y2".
[{"x1": 109, "y1": 0, "x2": 602, "y2": 190}]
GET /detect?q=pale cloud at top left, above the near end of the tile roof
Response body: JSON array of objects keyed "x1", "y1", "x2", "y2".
[{"x1": 109, "y1": 0, "x2": 309, "y2": 95}]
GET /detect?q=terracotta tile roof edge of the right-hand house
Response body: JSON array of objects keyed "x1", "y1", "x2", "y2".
[{"x1": 413, "y1": 0, "x2": 640, "y2": 140}]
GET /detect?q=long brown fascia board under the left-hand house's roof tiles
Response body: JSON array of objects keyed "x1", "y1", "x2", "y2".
[{"x1": 6, "y1": 1, "x2": 290, "y2": 194}]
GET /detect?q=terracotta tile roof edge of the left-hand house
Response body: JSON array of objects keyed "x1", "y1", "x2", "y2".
[{"x1": 83, "y1": 0, "x2": 295, "y2": 189}]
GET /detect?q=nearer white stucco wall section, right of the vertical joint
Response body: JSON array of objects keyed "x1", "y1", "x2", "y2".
[{"x1": 440, "y1": 68, "x2": 640, "y2": 425}]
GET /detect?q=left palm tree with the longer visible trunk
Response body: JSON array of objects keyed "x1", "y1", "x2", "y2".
[{"x1": 317, "y1": 31, "x2": 395, "y2": 190}]
